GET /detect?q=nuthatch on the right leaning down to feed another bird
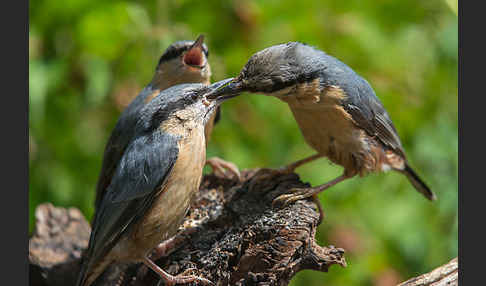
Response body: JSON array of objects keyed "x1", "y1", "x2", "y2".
[{"x1": 208, "y1": 42, "x2": 436, "y2": 219}]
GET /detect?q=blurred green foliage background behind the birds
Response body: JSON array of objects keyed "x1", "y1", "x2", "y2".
[{"x1": 29, "y1": 0, "x2": 458, "y2": 286}]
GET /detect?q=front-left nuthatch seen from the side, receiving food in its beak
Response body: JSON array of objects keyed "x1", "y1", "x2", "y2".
[{"x1": 77, "y1": 80, "x2": 235, "y2": 286}]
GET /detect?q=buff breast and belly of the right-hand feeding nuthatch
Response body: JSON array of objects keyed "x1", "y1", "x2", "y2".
[{"x1": 277, "y1": 79, "x2": 376, "y2": 172}]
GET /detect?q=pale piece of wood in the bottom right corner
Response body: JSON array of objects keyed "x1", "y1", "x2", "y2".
[{"x1": 398, "y1": 257, "x2": 459, "y2": 286}]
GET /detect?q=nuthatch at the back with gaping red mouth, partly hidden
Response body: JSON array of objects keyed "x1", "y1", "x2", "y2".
[{"x1": 95, "y1": 35, "x2": 239, "y2": 214}]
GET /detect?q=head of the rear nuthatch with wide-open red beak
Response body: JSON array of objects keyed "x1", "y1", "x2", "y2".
[{"x1": 152, "y1": 35, "x2": 211, "y2": 89}]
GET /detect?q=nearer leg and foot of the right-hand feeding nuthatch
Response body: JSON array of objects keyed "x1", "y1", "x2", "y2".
[{"x1": 272, "y1": 173, "x2": 350, "y2": 223}]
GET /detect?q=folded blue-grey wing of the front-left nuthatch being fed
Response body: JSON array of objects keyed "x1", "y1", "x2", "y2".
[{"x1": 80, "y1": 130, "x2": 179, "y2": 282}]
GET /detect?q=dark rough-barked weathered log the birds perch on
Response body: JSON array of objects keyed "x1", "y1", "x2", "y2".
[{"x1": 29, "y1": 170, "x2": 346, "y2": 286}]
